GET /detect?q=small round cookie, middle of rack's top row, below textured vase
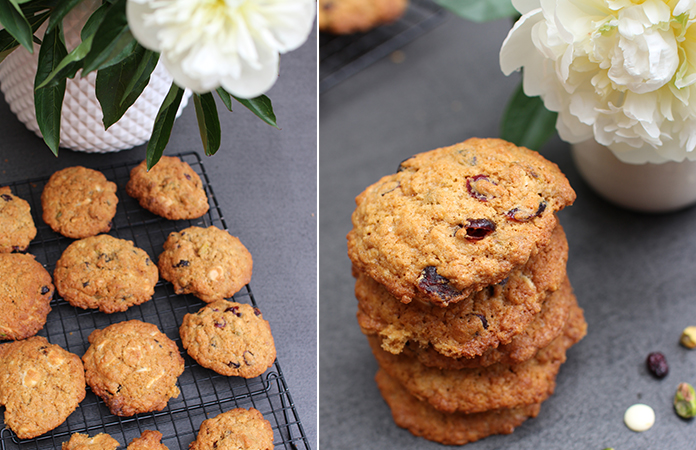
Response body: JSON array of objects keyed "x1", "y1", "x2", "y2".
[{"x1": 41, "y1": 166, "x2": 118, "y2": 239}]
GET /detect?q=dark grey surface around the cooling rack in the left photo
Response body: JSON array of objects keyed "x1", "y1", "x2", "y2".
[{"x1": 0, "y1": 27, "x2": 318, "y2": 448}]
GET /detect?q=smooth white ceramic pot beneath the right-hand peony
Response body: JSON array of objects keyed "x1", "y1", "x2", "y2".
[{"x1": 571, "y1": 140, "x2": 696, "y2": 213}]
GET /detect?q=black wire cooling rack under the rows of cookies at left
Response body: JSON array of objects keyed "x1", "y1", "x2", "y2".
[{"x1": 0, "y1": 153, "x2": 310, "y2": 450}]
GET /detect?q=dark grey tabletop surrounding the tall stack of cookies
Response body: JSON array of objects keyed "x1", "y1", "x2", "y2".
[{"x1": 319, "y1": 12, "x2": 696, "y2": 450}]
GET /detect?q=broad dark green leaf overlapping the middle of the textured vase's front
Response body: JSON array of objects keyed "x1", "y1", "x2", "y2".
[{"x1": 96, "y1": 45, "x2": 159, "y2": 129}]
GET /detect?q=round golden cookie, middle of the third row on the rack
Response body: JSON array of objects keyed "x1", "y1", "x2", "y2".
[{"x1": 82, "y1": 320, "x2": 184, "y2": 416}]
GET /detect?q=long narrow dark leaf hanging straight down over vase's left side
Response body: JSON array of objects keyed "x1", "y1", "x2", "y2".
[{"x1": 34, "y1": 26, "x2": 68, "y2": 156}]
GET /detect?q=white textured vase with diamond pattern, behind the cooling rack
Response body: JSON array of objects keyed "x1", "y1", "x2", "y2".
[{"x1": 0, "y1": 0, "x2": 191, "y2": 152}]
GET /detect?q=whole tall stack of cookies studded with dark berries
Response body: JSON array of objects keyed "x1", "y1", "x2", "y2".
[{"x1": 348, "y1": 139, "x2": 586, "y2": 445}]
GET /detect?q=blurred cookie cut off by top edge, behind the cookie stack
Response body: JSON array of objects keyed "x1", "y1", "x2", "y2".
[{"x1": 318, "y1": 0, "x2": 408, "y2": 34}]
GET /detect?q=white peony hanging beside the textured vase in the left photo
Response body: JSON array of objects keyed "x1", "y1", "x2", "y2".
[{"x1": 126, "y1": 0, "x2": 316, "y2": 98}]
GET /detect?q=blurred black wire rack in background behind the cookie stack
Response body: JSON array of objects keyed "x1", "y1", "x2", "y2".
[{"x1": 319, "y1": 0, "x2": 447, "y2": 94}]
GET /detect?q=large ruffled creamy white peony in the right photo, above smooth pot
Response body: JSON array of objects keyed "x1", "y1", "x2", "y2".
[{"x1": 500, "y1": 0, "x2": 696, "y2": 163}]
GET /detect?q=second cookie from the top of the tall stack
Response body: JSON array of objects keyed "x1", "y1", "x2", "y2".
[{"x1": 355, "y1": 226, "x2": 568, "y2": 358}]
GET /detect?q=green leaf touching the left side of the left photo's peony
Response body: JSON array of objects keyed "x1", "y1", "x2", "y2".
[{"x1": 81, "y1": 0, "x2": 135, "y2": 77}]
